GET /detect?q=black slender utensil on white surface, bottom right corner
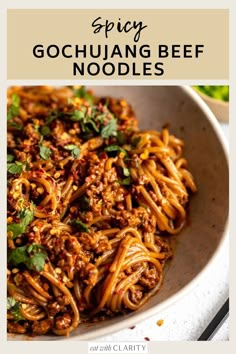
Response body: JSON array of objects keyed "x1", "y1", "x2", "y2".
[{"x1": 198, "y1": 298, "x2": 229, "y2": 341}]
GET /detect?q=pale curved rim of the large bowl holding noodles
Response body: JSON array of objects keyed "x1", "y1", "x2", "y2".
[{"x1": 8, "y1": 85, "x2": 229, "y2": 341}]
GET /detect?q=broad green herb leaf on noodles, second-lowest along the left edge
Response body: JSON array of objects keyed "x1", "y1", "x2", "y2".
[{"x1": 8, "y1": 243, "x2": 47, "y2": 272}]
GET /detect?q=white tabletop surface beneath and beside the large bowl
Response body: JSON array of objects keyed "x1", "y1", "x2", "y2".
[{"x1": 99, "y1": 123, "x2": 229, "y2": 342}]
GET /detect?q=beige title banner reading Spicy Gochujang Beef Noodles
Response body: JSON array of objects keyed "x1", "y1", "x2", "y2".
[{"x1": 7, "y1": 9, "x2": 229, "y2": 80}]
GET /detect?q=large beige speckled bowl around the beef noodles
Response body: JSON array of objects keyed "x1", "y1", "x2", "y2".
[{"x1": 9, "y1": 86, "x2": 229, "y2": 340}]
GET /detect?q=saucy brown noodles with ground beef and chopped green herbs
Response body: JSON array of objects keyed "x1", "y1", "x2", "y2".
[{"x1": 7, "y1": 86, "x2": 196, "y2": 336}]
